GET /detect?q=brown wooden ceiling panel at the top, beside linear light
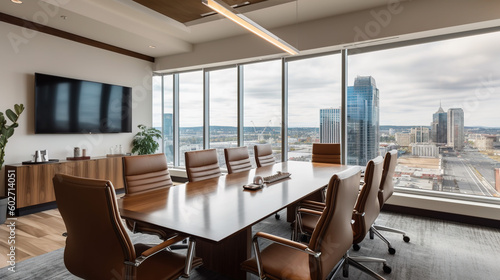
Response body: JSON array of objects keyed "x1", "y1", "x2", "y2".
[{"x1": 134, "y1": 0, "x2": 265, "y2": 23}]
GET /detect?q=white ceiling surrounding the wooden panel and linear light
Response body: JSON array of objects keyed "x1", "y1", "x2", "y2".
[{"x1": 0, "y1": 0, "x2": 394, "y2": 57}]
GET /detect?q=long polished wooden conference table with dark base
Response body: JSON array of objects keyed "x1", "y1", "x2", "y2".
[{"x1": 118, "y1": 161, "x2": 349, "y2": 279}]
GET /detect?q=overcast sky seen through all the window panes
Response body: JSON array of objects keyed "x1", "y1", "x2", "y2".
[{"x1": 154, "y1": 32, "x2": 500, "y2": 127}]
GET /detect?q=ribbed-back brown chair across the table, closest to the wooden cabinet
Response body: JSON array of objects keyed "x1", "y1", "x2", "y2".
[{"x1": 122, "y1": 154, "x2": 182, "y2": 241}]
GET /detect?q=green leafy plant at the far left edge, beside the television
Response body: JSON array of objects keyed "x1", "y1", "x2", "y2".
[{"x1": 0, "y1": 104, "x2": 24, "y2": 224}]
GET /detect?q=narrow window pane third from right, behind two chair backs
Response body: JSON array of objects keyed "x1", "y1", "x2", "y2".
[{"x1": 243, "y1": 60, "x2": 282, "y2": 164}]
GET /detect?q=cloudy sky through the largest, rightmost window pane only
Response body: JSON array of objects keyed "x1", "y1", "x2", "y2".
[{"x1": 349, "y1": 32, "x2": 500, "y2": 127}]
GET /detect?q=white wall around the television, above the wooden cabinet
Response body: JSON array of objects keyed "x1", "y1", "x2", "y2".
[{"x1": 0, "y1": 22, "x2": 153, "y2": 195}]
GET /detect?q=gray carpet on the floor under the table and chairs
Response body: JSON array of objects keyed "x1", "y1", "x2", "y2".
[{"x1": 0, "y1": 212, "x2": 500, "y2": 280}]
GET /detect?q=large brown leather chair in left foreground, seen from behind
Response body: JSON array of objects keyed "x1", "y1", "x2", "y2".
[{"x1": 53, "y1": 174, "x2": 202, "y2": 279}]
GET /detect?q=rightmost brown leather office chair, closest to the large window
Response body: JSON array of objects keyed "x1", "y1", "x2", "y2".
[{"x1": 370, "y1": 150, "x2": 410, "y2": 255}]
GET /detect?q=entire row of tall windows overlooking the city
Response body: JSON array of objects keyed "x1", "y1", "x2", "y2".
[{"x1": 153, "y1": 28, "x2": 500, "y2": 201}]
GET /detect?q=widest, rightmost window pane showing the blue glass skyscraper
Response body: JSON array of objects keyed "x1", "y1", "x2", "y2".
[{"x1": 347, "y1": 32, "x2": 500, "y2": 197}]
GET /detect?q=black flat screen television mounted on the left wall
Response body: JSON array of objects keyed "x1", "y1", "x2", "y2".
[{"x1": 35, "y1": 73, "x2": 132, "y2": 134}]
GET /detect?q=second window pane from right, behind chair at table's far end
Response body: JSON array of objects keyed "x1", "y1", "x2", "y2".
[{"x1": 287, "y1": 54, "x2": 342, "y2": 161}]
